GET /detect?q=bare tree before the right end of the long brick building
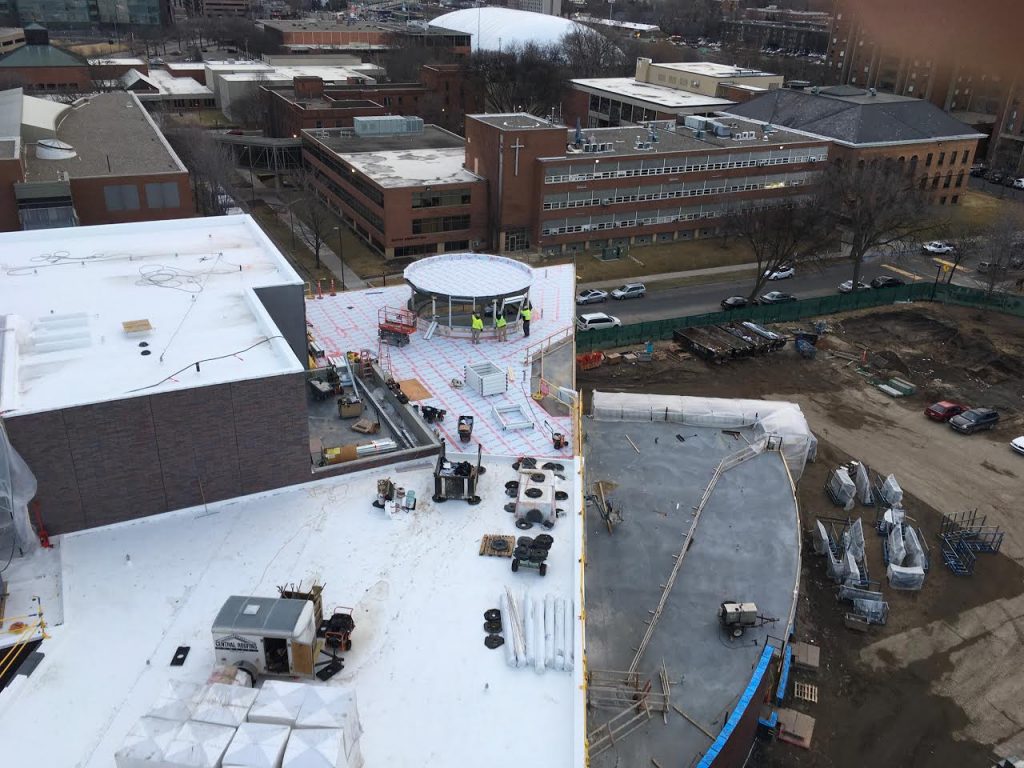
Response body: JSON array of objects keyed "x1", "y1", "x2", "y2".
[{"x1": 725, "y1": 196, "x2": 831, "y2": 301}]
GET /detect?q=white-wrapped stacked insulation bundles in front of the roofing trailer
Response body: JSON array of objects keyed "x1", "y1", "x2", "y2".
[{"x1": 115, "y1": 680, "x2": 364, "y2": 768}]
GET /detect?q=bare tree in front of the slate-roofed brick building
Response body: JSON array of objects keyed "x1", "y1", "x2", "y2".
[{"x1": 822, "y1": 160, "x2": 933, "y2": 285}]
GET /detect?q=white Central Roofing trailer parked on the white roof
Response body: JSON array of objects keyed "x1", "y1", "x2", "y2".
[{"x1": 212, "y1": 595, "x2": 324, "y2": 677}]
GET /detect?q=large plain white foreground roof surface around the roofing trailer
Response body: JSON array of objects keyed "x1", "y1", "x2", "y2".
[{"x1": 3, "y1": 454, "x2": 586, "y2": 768}]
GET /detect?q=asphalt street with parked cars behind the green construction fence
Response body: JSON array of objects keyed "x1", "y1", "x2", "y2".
[{"x1": 578, "y1": 254, "x2": 977, "y2": 323}]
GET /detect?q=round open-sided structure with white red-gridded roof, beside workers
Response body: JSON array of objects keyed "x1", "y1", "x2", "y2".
[{"x1": 403, "y1": 253, "x2": 534, "y2": 327}]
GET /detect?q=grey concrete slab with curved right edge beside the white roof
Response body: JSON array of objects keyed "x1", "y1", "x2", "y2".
[{"x1": 585, "y1": 421, "x2": 800, "y2": 768}]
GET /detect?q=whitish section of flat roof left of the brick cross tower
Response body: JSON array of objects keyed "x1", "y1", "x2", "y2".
[{"x1": 339, "y1": 147, "x2": 480, "y2": 187}]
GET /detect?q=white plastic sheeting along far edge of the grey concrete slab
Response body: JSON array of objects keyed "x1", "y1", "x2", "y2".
[{"x1": 593, "y1": 391, "x2": 817, "y2": 479}]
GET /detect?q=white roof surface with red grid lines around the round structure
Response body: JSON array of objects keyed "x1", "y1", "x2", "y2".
[{"x1": 306, "y1": 264, "x2": 575, "y2": 460}]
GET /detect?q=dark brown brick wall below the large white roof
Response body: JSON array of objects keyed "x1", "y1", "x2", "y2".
[{"x1": 6, "y1": 374, "x2": 311, "y2": 534}]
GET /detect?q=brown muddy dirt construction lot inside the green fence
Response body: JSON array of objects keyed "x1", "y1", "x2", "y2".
[{"x1": 580, "y1": 304, "x2": 1024, "y2": 768}]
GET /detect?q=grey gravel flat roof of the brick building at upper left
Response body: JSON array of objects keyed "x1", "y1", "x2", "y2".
[{"x1": 25, "y1": 91, "x2": 185, "y2": 181}]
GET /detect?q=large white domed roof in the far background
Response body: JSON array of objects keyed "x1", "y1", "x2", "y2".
[{"x1": 430, "y1": 8, "x2": 588, "y2": 50}]
